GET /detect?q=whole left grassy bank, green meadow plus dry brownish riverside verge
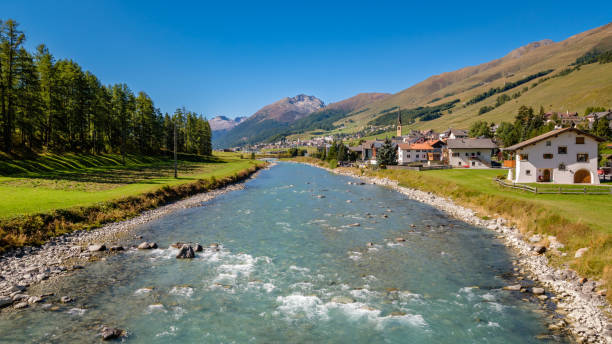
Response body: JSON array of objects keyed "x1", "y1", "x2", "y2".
[{"x1": 0, "y1": 153, "x2": 263, "y2": 250}]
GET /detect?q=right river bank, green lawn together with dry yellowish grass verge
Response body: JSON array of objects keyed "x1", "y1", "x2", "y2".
[{"x1": 296, "y1": 158, "x2": 612, "y2": 301}]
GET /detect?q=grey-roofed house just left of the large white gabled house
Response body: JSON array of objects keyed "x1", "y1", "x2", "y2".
[{"x1": 445, "y1": 138, "x2": 497, "y2": 168}]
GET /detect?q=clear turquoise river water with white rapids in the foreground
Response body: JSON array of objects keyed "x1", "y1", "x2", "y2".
[{"x1": 0, "y1": 163, "x2": 566, "y2": 344}]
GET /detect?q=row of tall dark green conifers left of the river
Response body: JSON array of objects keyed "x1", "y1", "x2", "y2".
[{"x1": 0, "y1": 19, "x2": 212, "y2": 155}]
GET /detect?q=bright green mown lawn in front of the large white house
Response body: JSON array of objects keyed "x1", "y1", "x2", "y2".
[{"x1": 420, "y1": 169, "x2": 612, "y2": 233}]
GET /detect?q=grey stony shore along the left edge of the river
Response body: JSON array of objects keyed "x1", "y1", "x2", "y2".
[{"x1": 0, "y1": 168, "x2": 258, "y2": 310}]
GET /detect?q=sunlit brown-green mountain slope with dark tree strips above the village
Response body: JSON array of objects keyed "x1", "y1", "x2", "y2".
[{"x1": 334, "y1": 23, "x2": 612, "y2": 132}]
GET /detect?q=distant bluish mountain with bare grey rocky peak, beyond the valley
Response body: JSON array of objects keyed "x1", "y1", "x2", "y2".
[{"x1": 213, "y1": 94, "x2": 325, "y2": 148}]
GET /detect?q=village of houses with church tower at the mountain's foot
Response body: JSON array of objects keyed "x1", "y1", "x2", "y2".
[{"x1": 240, "y1": 110, "x2": 612, "y2": 185}]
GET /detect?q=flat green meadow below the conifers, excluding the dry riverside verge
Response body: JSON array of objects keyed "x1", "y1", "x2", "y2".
[{"x1": 0, "y1": 153, "x2": 257, "y2": 218}]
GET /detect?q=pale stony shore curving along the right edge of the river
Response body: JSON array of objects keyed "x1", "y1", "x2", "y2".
[{"x1": 302, "y1": 164, "x2": 612, "y2": 343}]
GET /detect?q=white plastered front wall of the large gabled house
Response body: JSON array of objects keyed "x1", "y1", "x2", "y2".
[{"x1": 514, "y1": 131, "x2": 599, "y2": 184}]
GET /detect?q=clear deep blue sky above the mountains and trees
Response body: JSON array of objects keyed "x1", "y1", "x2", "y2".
[{"x1": 0, "y1": 0, "x2": 612, "y2": 117}]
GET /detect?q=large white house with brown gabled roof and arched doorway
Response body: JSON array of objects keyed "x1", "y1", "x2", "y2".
[{"x1": 504, "y1": 128, "x2": 603, "y2": 184}]
